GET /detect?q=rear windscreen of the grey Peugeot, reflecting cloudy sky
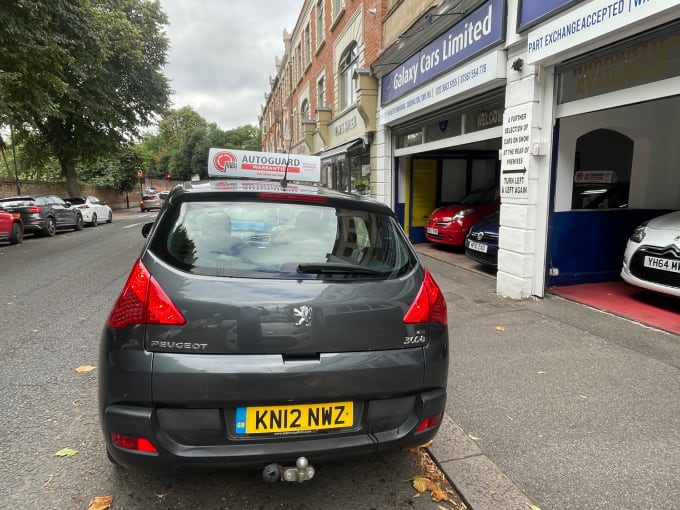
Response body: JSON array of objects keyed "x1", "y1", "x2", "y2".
[{"x1": 150, "y1": 202, "x2": 416, "y2": 279}]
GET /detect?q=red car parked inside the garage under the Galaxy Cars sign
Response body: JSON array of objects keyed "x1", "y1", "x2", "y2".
[{"x1": 425, "y1": 186, "x2": 501, "y2": 246}]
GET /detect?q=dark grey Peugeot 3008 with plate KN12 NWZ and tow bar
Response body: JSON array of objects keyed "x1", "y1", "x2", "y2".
[{"x1": 99, "y1": 157, "x2": 448, "y2": 481}]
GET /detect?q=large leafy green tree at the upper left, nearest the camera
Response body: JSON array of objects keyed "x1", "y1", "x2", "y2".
[{"x1": 0, "y1": 0, "x2": 170, "y2": 196}]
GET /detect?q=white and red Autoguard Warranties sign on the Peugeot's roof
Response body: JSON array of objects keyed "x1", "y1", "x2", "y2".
[{"x1": 208, "y1": 148, "x2": 321, "y2": 182}]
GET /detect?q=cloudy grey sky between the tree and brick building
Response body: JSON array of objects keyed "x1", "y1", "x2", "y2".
[{"x1": 160, "y1": 0, "x2": 304, "y2": 131}]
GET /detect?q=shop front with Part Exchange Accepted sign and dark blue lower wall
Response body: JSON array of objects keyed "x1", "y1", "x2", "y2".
[{"x1": 524, "y1": 0, "x2": 680, "y2": 286}]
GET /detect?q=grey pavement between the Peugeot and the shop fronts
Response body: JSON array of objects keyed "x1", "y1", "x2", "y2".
[{"x1": 416, "y1": 244, "x2": 680, "y2": 510}]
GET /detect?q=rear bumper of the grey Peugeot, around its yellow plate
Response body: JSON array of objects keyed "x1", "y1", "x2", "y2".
[{"x1": 102, "y1": 388, "x2": 446, "y2": 471}]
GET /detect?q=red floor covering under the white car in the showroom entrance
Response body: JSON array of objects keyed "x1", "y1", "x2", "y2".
[{"x1": 549, "y1": 281, "x2": 680, "y2": 335}]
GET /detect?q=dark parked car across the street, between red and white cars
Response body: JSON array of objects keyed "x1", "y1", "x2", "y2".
[{"x1": 0, "y1": 195, "x2": 83, "y2": 236}]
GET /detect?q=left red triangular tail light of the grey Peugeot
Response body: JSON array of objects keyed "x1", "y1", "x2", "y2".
[{"x1": 106, "y1": 260, "x2": 186, "y2": 328}]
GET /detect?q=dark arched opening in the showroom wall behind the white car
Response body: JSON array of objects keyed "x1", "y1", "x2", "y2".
[{"x1": 571, "y1": 129, "x2": 634, "y2": 210}]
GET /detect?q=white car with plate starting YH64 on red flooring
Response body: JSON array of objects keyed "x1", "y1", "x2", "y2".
[{"x1": 621, "y1": 211, "x2": 680, "y2": 297}]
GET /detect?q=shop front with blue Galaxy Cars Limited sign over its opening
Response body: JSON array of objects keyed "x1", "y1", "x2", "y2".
[{"x1": 377, "y1": 0, "x2": 506, "y2": 243}]
